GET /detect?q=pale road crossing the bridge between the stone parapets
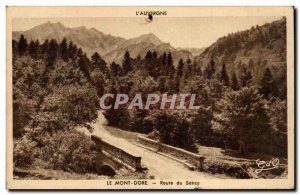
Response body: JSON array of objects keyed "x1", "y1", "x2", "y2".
[{"x1": 89, "y1": 112, "x2": 216, "y2": 179}]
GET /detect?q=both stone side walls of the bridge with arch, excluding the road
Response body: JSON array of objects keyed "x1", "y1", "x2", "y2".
[{"x1": 91, "y1": 135, "x2": 204, "y2": 176}]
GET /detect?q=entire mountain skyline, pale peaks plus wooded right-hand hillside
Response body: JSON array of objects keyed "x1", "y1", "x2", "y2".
[{"x1": 13, "y1": 18, "x2": 287, "y2": 87}]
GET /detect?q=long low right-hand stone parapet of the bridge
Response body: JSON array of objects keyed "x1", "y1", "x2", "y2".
[{"x1": 138, "y1": 136, "x2": 205, "y2": 170}]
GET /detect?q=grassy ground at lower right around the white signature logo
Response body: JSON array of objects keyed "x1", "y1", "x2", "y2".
[{"x1": 198, "y1": 145, "x2": 287, "y2": 179}]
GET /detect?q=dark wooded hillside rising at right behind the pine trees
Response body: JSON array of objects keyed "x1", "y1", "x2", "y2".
[{"x1": 195, "y1": 18, "x2": 287, "y2": 97}]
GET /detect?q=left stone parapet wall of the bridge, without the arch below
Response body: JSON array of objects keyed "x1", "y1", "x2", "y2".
[{"x1": 91, "y1": 135, "x2": 142, "y2": 171}]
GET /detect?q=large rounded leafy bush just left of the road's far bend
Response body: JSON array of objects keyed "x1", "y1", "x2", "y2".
[{"x1": 30, "y1": 85, "x2": 98, "y2": 132}]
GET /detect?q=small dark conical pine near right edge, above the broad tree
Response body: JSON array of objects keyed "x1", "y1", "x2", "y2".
[{"x1": 259, "y1": 67, "x2": 278, "y2": 98}]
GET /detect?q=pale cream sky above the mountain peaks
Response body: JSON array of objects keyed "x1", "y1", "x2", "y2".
[{"x1": 13, "y1": 16, "x2": 281, "y2": 48}]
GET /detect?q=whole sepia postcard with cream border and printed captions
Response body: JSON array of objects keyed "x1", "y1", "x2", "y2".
[{"x1": 6, "y1": 6, "x2": 295, "y2": 190}]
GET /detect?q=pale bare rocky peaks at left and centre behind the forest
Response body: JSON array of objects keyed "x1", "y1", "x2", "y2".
[{"x1": 12, "y1": 22, "x2": 192, "y2": 63}]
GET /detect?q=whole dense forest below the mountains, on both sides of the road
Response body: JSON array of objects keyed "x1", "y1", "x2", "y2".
[{"x1": 12, "y1": 18, "x2": 287, "y2": 173}]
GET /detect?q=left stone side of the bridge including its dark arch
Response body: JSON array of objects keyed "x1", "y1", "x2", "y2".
[{"x1": 91, "y1": 135, "x2": 143, "y2": 176}]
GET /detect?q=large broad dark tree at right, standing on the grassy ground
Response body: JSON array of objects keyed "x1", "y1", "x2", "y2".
[{"x1": 213, "y1": 87, "x2": 271, "y2": 154}]
